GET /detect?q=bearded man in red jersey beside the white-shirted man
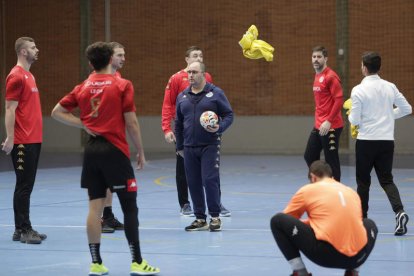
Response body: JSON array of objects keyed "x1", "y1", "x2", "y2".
[{"x1": 304, "y1": 46, "x2": 343, "y2": 181}]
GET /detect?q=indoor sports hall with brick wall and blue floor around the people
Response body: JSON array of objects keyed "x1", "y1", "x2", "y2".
[{"x1": 0, "y1": 0, "x2": 414, "y2": 276}]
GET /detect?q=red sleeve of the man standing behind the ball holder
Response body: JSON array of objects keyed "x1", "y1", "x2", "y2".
[{"x1": 161, "y1": 75, "x2": 180, "y2": 133}]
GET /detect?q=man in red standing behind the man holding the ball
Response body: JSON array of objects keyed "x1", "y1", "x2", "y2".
[{"x1": 161, "y1": 46, "x2": 231, "y2": 217}]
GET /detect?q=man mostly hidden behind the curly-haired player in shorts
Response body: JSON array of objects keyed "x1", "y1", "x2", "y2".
[{"x1": 102, "y1": 42, "x2": 125, "y2": 233}]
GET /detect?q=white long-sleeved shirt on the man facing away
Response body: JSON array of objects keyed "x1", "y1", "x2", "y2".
[{"x1": 348, "y1": 74, "x2": 412, "y2": 140}]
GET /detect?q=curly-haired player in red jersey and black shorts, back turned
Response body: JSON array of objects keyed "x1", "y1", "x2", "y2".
[{"x1": 52, "y1": 42, "x2": 160, "y2": 275}]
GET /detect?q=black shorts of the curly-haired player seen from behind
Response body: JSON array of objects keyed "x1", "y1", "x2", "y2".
[{"x1": 81, "y1": 136, "x2": 138, "y2": 200}]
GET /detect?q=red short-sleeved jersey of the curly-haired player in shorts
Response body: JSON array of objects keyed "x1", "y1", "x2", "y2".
[{"x1": 59, "y1": 74, "x2": 136, "y2": 157}]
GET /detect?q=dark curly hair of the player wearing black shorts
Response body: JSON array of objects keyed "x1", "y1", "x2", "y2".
[{"x1": 85, "y1": 41, "x2": 114, "y2": 71}]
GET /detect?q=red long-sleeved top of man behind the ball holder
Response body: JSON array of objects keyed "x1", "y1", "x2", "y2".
[{"x1": 161, "y1": 69, "x2": 213, "y2": 133}]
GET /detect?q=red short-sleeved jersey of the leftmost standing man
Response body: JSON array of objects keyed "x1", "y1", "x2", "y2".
[{"x1": 6, "y1": 65, "x2": 43, "y2": 144}]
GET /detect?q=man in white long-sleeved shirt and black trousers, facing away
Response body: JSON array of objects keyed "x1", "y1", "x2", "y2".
[{"x1": 348, "y1": 52, "x2": 412, "y2": 236}]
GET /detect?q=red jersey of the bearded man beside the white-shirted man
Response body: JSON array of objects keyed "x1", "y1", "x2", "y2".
[{"x1": 313, "y1": 67, "x2": 344, "y2": 129}]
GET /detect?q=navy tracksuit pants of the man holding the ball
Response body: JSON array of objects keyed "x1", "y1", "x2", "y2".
[{"x1": 184, "y1": 145, "x2": 220, "y2": 219}]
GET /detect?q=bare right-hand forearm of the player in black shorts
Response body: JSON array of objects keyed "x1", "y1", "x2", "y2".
[{"x1": 124, "y1": 112, "x2": 145, "y2": 170}]
